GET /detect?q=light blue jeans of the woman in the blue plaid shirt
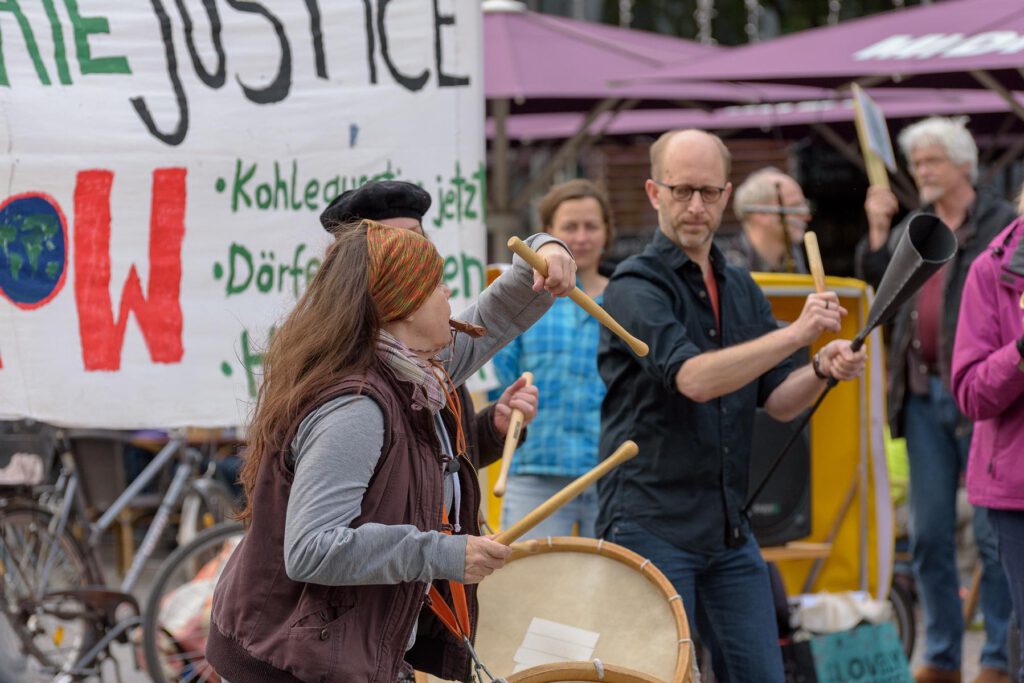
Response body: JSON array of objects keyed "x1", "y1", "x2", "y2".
[{"x1": 502, "y1": 474, "x2": 597, "y2": 541}]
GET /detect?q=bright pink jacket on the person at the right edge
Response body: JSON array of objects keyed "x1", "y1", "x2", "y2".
[{"x1": 952, "y1": 218, "x2": 1024, "y2": 510}]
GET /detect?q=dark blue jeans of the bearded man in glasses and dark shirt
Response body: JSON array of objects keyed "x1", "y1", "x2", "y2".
[{"x1": 607, "y1": 520, "x2": 784, "y2": 683}]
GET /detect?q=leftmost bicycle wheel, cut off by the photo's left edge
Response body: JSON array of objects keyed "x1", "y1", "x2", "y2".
[{"x1": 0, "y1": 507, "x2": 100, "y2": 673}]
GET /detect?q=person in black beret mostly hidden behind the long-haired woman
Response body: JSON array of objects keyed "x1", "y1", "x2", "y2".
[{"x1": 319, "y1": 180, "x2": 540, "y2": 479}]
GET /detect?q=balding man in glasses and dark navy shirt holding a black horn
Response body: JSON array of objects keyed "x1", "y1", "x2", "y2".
[{"x1": 597, "y1": 130, "x2": 865, "y2": 683}]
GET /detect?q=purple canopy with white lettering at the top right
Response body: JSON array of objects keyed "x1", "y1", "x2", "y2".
[{"x1": 631, "y1": 0, "x2": 1024, "y2": 90}]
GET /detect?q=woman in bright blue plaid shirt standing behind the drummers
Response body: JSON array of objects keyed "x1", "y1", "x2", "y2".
[{"x1": 495, "y1": 179, "x2": 612, "y2": 538}]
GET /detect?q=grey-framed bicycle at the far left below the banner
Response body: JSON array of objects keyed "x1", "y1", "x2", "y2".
[{"x1": 0, "y1": 430, "x2": 233, "y2": 682}]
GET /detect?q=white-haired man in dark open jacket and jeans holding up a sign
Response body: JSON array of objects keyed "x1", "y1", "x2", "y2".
[{"x1": 855, "y1": 117, "x2": 1016, "y2": 683}]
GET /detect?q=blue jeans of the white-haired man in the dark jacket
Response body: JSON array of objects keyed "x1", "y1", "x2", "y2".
[{"x1": 905, "y1": 378, "x2": 1010, "y2": 671}]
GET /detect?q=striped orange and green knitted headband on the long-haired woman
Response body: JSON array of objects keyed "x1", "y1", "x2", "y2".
[{"x1": 362, "y1": 220, "x2": 444, "y2": 323}]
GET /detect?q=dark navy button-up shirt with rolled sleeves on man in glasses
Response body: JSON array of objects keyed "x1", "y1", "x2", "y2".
[{"x1": 597, "y1": 231, "x2": 793, "y2": 554}]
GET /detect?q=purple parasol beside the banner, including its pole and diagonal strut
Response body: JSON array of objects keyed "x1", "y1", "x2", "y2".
[{"x1": 483, "y1": 0, "x2": 827, "y2": 219}]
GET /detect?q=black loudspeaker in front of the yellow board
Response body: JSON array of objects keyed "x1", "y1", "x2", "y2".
[{"x1": 750, "y1": 348, "x2": 811, "y2": 547}]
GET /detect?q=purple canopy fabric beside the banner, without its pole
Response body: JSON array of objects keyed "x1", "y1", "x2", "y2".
[{"x1": 483, "y1": 0, "x2": 821, "y2": 112}]
